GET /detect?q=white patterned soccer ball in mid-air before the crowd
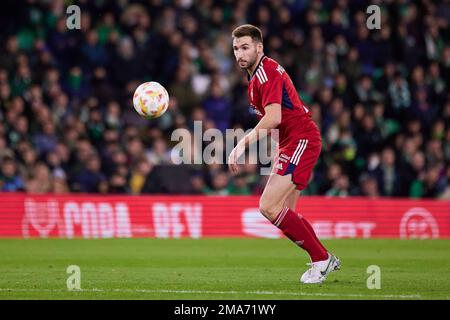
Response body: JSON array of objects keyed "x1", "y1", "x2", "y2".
[{"x1": 133, "y1": 81, "x2": 169, "y2": 119}]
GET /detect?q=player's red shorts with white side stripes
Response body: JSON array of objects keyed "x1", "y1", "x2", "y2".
[{"x1": 272, "y1": 134, "x2": 322, "y2": 190}]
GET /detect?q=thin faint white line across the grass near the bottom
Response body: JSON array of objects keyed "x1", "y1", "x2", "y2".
[{"x1": 0, "y1": 288, "x2": 421, "y2": 299}]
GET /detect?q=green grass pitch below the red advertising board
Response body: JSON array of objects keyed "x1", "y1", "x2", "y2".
[{"x1": 0, "y1": 239, "x2": 450, "y2": 300}]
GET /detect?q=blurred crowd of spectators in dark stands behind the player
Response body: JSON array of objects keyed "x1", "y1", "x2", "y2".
[{"x1": 0, "y1": 0, "x2": 450, "y2": 199}]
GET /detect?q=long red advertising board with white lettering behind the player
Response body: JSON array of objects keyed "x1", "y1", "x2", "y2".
[{"x1": 0, "y1": 193, "x2": 450, "y2": 239}]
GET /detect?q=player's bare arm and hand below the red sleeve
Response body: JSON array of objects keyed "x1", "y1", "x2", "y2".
[{"x1": 228, "y1": 103, "x2": 281, "y2": 173}]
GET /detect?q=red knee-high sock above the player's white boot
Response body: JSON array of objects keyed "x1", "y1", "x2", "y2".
[{"x1": 272, "y1": 207, "x2": 328, "y2": 262}]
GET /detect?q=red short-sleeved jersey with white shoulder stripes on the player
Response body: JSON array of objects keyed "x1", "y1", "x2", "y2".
[{"x1": 248, "y1": 56, "x2": 320, "y2": 148}]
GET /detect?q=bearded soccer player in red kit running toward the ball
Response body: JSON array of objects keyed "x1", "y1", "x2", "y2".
[{"x1": 228, "y1": 24, "x2": 341, "y2": 283}]
